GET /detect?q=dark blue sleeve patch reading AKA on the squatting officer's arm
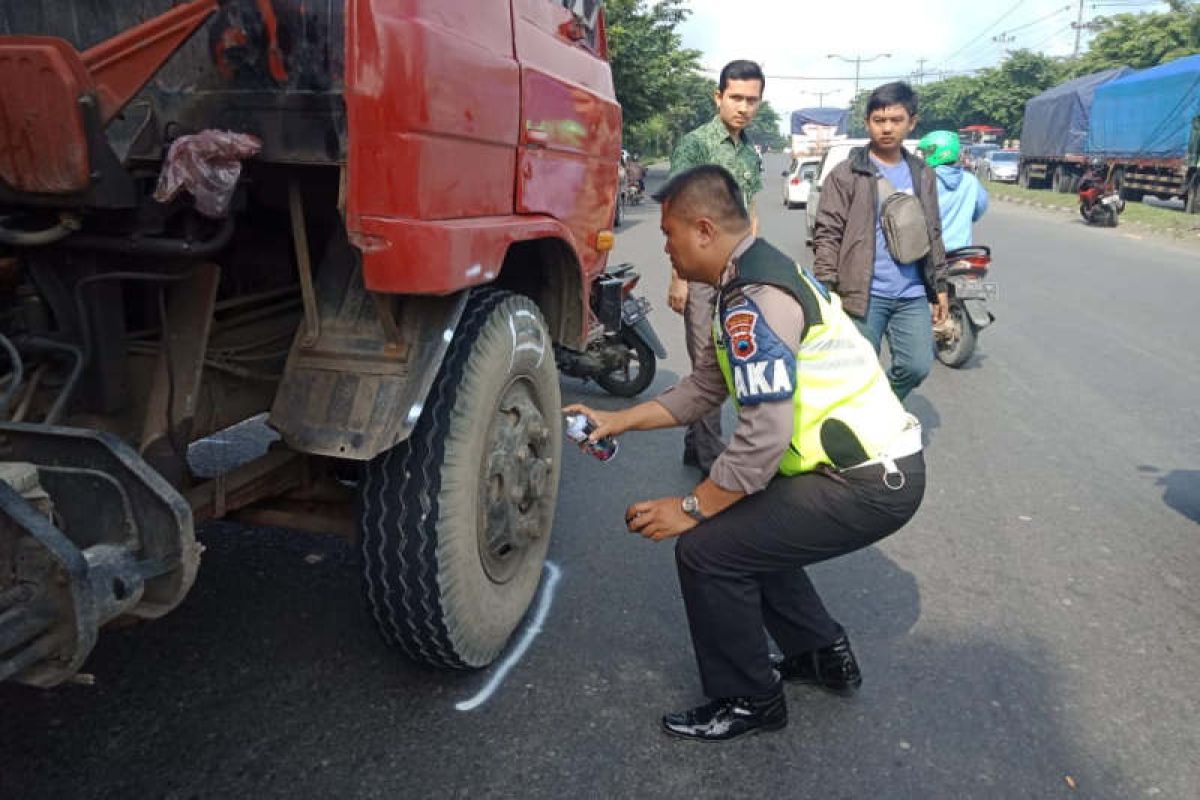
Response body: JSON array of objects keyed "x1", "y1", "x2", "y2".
[{"x1": 721, "y1": 299, "x2": 796, "y2": 405}]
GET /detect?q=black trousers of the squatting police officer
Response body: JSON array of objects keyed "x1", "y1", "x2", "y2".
[{"x1": 676, "y1": 453, "x2": 925, "y2": 698}]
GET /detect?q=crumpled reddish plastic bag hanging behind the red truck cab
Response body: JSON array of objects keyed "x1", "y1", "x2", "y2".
[{"x1": 154, "y1": 131, "x2": 263, "y2": 219}]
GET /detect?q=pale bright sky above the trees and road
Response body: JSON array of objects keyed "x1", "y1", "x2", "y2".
[{"x1": 679, "y1": 0, "x2": 1166, "y2": 133}]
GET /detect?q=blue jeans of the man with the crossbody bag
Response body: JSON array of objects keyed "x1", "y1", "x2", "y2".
[{"x1": 854, "y1": 295, "x2": 934, "y2": 399}]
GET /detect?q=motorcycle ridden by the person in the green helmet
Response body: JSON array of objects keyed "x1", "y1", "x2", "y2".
[{"x1": 934, "y1": 245, "x2": 996, "y2": 367}]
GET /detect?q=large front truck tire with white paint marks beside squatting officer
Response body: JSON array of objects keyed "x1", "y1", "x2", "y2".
[{"x1": 359, "y1": 289, "x2": 562, "y2": 669}]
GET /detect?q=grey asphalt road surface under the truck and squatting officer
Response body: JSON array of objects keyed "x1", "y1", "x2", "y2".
[{"x1": 0, "y1": 156, "x2": 1200, "y2": 800}]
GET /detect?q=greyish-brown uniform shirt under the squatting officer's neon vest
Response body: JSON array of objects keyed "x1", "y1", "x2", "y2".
[{"x1": 655, "y1": 236, "x2": 804, "y2": 494}]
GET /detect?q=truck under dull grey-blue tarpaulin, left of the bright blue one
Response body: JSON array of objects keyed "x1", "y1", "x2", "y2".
[{"x1": 1018, "y1": 67, "x2": 1132, "y2": 192}]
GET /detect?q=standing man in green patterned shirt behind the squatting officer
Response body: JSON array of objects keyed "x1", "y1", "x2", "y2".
[{"x1": 667, "y1": 60, "x2": 767, "y2": 475}]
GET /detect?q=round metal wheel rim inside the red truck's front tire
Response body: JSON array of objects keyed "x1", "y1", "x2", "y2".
[{"x1": 479, "y1": 378, "x2": 553, "y2": 583}]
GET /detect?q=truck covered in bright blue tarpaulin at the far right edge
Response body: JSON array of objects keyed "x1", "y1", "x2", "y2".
[{"x1": 1086, "y1": 55, "x2": 1200, "y2": 213}]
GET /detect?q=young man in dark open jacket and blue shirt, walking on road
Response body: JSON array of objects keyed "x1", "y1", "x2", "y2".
[{"x1": 812, "y1": 83, "x2": 948, "y2": 399}]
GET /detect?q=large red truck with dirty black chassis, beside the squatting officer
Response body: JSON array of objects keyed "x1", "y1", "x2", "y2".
[{"x1": 0, "y1": 0, "x2": 620, "y2": 686}]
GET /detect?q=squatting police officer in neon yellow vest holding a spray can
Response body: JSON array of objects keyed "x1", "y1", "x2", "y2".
[{"x1": 564, "y1": 164, "x2": 925, "y2": 741}]
